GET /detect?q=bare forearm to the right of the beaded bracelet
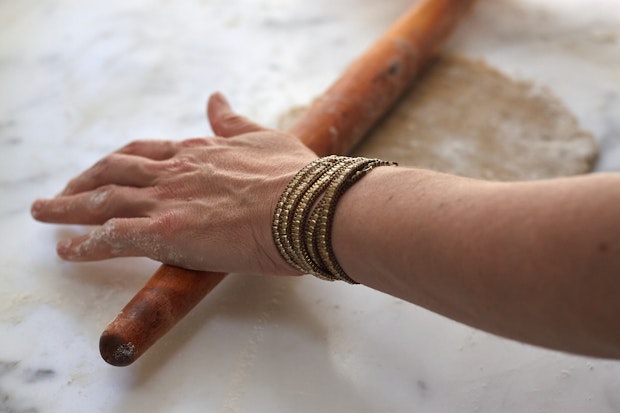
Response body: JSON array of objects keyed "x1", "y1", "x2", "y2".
[{"x1": 333, "y1": 168, "x2": 620, "y2": 357}]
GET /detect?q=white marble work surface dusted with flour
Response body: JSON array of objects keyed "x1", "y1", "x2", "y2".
[{"x1": 0, "y1": 0, "x2": 620, "y2": 412}]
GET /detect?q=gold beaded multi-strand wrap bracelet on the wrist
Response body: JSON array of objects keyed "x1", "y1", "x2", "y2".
[{"x1": 271, "y1": 155, "x2": 397, "y2": 284}]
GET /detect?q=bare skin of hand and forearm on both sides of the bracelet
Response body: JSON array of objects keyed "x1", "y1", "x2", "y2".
[{"x1": 32, "y1": 94, "x2": 620, "y2": 358}]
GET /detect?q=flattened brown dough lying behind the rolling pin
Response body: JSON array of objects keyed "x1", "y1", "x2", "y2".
[{"x1": 280, "y1": 57, "x2": 598, "y2": 181}]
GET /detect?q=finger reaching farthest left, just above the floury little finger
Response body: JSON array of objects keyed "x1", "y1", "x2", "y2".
[{"x1": 31, "y1": 185, "x2": 155, "y2": 225}]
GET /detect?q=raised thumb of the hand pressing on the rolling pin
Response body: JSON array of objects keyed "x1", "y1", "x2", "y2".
[{"x1": 207, "y1": 93, "x2": 266, "y2": 138}]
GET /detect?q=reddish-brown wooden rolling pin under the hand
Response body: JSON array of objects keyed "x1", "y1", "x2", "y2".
[{"x1": 99, "y1": 0, "x2": 475, "y2": 366}]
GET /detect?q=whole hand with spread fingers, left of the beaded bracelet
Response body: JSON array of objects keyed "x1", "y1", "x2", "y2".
[{"x1": 32, "y1": 94, "x2": 316, "y2": 274}]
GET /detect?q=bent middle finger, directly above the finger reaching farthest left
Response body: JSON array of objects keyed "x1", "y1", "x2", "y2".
[{"x1": 60, "y1": 153, "x2": 158, "y2": 195}]
